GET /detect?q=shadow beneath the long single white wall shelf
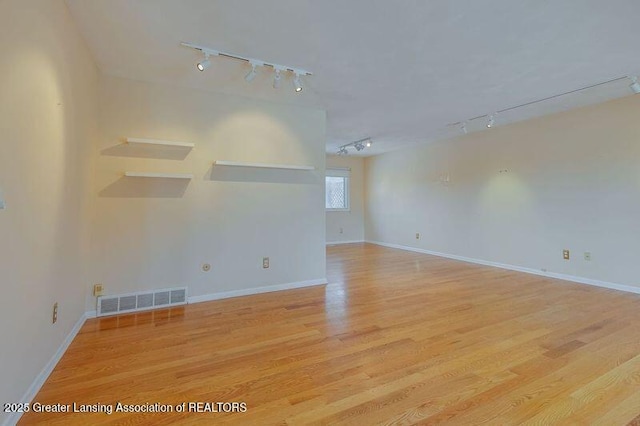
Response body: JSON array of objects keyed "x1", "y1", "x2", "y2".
[{"x1": 207, "y1": 165, "x2": 324, "y2": 185}]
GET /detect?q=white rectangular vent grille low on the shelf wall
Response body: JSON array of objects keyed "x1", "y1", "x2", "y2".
[{"x1": 98, "y1": 287, "x2": 187, "y2": 317}]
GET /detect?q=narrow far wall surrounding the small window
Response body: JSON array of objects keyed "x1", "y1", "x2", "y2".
[{"x1": 327, "y1": 155, "x2": 364, "y2": 244}]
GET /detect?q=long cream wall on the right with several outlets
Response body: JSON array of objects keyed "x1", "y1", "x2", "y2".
[{"x1": 365, "y1": 96, "x2": 640, "y2": 287}]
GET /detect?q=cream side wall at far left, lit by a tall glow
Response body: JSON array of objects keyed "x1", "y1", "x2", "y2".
[{"x1": 0, "y1": 0, "x2": 97, "y2": 424}]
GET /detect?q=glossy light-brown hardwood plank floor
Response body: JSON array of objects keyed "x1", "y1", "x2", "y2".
[{"x1": 20, "y1": 244, "x2": 640, "y2": 425}]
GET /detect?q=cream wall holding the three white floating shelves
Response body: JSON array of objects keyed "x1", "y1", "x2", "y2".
[{"x1": 87, "y1": 73, "x2": 326, "y2": 309}]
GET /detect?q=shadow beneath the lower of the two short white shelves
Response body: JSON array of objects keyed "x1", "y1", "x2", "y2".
[{"x1": 98, "y1": 176, "x2": 190, "y2": 198}]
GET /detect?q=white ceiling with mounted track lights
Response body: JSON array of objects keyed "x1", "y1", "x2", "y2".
[{"x1": 67, "y1": 0, "x2": 640, "y2": 155}]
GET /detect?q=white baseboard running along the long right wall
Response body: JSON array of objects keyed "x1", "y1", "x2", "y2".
[{"x1": 366, "y1": 240, "x2": 640, "y2": 294}]
